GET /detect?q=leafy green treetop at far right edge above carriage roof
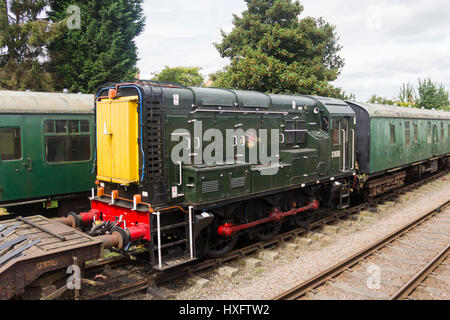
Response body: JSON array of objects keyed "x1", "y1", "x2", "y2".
[{"x1": 416, "y1": 78, "x2": 450, "y2": 109}]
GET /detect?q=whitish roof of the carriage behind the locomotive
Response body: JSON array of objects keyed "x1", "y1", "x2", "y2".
[{"x1": 351, "y1": 101, "x2": 450, "y2": 120}]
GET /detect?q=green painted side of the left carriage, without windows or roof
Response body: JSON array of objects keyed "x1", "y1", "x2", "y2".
[{"x1": 0, "y1": 113, "x2": 95, "y2": 204}]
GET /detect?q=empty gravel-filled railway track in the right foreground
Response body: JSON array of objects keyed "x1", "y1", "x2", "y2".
[{"x1": 273, "y1": 201, "x2": 450, "y2": 300}]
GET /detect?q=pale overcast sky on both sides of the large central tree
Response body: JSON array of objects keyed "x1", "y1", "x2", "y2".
[{"x1": 136, "y1": 0, "x2": 450, "y2": 101}]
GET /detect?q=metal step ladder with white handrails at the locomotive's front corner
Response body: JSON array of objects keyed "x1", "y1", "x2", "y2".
[{"x1": 151, "y1": 207, "x2": 196, "y2": 271}]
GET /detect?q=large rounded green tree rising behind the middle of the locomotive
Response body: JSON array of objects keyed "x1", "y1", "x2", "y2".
[{"x1": 213, "y1": 0, "x2": 344, "y2": 96}]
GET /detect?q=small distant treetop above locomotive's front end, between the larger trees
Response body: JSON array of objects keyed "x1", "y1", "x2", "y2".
[{"x1": 152, "y1": 66, "x2": 205, "y2": 87}]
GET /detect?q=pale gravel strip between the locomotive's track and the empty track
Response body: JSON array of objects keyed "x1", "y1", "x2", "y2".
[{"x1": 163, "y1": 175, "x2": 450, "y2": 300}]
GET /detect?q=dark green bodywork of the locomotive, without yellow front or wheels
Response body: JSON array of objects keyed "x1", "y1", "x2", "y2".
[{"x1": 99, "y1": 83, "x2": 355, "y2": 209}]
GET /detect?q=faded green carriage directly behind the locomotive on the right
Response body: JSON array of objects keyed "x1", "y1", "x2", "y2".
[{"x1": 348, "y1": 102, "x2": 450, "y2": 196}]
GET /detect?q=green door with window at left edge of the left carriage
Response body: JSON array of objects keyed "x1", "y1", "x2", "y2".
[{"x1": 0, "y1": 115, "x2": 24, "y2": 202}]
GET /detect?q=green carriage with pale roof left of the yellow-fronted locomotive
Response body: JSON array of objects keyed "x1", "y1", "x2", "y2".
[{"x1": 0, "y1": 91, "x2": 95, "y2": 213}]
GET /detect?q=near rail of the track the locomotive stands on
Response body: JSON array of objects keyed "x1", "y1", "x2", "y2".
[{"x1": 82, "y1": 171, "x2": 448, "y2": 300}]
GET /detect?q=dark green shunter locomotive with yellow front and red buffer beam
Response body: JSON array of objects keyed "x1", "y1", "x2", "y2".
[{"x1": 86, "y1": 82, "x2": 356, "y2": 269}]
